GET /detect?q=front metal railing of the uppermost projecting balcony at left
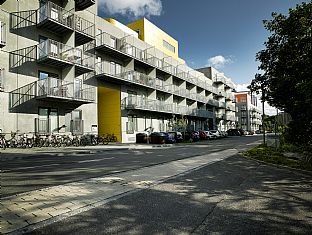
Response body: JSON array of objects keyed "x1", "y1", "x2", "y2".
[{"x1": 38, "y1": 1, "x2": 74, "y2": 29}]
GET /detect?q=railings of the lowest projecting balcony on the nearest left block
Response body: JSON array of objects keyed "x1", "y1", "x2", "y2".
[{"x1": 10, "y1": 77, "x2": 95, "y2": 110}]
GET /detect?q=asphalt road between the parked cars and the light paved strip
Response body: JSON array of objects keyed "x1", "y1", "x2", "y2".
[{"x1": 0, "y1": 136, "x2": 261, "y2": 197}]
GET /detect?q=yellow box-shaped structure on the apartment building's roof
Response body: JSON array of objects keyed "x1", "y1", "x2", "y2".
[{"x1": 128, "y1": 18, "x2": 179, "y2": 59}]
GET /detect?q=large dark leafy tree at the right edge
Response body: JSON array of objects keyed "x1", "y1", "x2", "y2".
[{"x1": 250, "y1": 2, "x2": 312, "y2": 144}]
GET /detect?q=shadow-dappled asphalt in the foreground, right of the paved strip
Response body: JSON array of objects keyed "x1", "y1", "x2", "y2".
[{"x1": 26, "y1": 156, "x2": 312, "y2": 235}]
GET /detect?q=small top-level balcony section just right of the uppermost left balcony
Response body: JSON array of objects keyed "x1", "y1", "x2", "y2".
[{"x1": 74, "y1": 15, "x2": 95, "y2": 46}]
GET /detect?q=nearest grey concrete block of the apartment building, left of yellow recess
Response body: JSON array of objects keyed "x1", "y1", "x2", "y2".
[{"x1": 0, "y1": 0, "x2": 97, "y2": 133}]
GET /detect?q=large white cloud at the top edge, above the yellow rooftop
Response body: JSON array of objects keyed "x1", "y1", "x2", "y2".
[{"x1": 99, "y1": 0, "x2": 162, "y2": 18}]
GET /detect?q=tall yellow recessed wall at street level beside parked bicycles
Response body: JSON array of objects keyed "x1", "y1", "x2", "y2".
[{"x1": 98, "y1": 87, "x2": 121, "y2": 142}]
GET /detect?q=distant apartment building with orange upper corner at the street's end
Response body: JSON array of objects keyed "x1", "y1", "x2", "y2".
[{"x1": 235, "y1": 91, "x2": 262, "y2": 131}]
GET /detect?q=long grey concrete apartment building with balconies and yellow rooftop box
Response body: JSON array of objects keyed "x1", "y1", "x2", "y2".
[{"x1": 0, "y1": 0, "x2": 235, "y2": 142}]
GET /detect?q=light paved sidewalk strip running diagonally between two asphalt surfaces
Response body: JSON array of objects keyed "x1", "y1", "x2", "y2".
[{"x1": 0, "y1": 149, "x2": 237, "y2": 234}]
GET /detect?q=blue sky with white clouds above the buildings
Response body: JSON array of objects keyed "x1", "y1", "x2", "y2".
[{"x1": 99, "y1": 0, "x2": 308, "y2": 113}]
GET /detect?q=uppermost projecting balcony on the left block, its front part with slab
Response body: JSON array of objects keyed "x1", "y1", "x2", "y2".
[{"x1": 37, "y1": 2, "x2": 74, "y2": 35}]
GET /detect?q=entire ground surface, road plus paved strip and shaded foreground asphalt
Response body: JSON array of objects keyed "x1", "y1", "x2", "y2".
[{"x1": 0, "y1": 136, "x2": 312, "y2": 235}]
